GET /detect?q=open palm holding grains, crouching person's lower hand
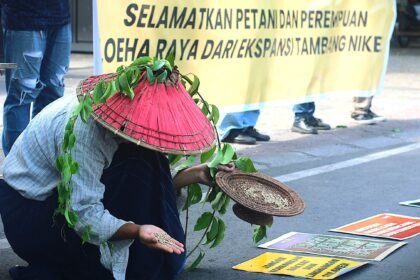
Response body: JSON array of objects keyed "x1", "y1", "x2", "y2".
[{"x1": 139, "y1": 225, "x2": 184, "y2": 255}]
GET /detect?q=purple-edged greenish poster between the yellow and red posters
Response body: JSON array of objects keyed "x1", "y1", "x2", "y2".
[{"x1": 258, "y1": 232, "x2": 406, "y2": 261}]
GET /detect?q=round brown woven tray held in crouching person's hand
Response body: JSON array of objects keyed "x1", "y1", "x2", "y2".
[{"x1": 216, "y1": 170, "x2": 305, "y2": 217}]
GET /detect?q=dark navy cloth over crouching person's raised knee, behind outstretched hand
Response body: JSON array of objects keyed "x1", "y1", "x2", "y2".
[{"x1": 101, "y1": 144, "x2": 185, "y2": 280}]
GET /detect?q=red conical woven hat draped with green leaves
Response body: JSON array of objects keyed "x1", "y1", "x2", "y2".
[{"x1": 77, "y1": 73, "x2": 216, "y2": 155}]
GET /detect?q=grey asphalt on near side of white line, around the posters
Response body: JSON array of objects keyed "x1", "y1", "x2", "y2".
[{"x1": 179, "y1": 144, "x2": 420, "y2": 280}]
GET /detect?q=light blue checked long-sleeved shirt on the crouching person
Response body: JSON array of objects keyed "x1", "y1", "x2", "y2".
[{"x1": 3, "y1": 96, "x2": 133, "y2": 279}]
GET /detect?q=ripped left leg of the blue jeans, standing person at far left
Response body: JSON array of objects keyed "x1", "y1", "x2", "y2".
[{"x1": 3, "y1": 29, "x2": 46, "y2": 155}]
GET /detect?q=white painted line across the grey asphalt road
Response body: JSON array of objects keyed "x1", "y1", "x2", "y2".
[{"x1": 275, "y1": 143, "x2": 420, "y2": 182}]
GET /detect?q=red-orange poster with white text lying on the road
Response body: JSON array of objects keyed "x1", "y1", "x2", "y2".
[{"x1": 330, "y1": 213, "x2": 420, "y2": 240}]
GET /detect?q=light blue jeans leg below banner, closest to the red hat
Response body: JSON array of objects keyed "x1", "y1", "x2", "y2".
[{"x1": 218, "y1": 110, "x2": 260, "y2": 140}]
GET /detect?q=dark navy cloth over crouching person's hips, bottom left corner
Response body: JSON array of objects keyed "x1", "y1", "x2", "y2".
[{"x1": 0, "y1": 180, "x2": 113, "y2": 280}]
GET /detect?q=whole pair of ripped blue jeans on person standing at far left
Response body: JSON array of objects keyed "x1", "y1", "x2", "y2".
[{"x1": 2, "y1": 24, "x2": 71, "y2": 155}]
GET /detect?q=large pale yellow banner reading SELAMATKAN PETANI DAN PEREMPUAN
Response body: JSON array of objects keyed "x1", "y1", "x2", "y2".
[{"x1": 93, "y1": 0, "x2": 396, "y2": 111}]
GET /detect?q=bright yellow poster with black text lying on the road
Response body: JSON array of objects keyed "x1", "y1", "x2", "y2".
[{"x1": 233, "y1": 253, "x2": 367, "y2": 279}]
